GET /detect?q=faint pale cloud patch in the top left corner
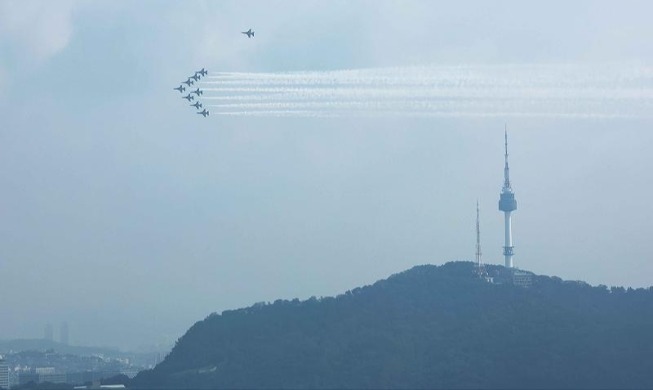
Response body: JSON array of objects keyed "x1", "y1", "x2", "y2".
[{"x1": 0, "y1": 0, "x2": 77, "y2": 62}]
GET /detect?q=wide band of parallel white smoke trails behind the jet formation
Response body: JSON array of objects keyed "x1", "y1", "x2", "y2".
[{"x1": 201, "y1": 65, "x2": 653, "y2": 118}]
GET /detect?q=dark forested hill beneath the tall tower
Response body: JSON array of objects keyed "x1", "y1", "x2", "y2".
[{"x1": 131, "y1": 262, "x2": 653, "y2": 388}]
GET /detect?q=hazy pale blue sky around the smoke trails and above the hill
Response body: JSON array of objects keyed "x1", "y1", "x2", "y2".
[{"x1": 0, "y1": 0, "x2": 653, "y2": 350}]
